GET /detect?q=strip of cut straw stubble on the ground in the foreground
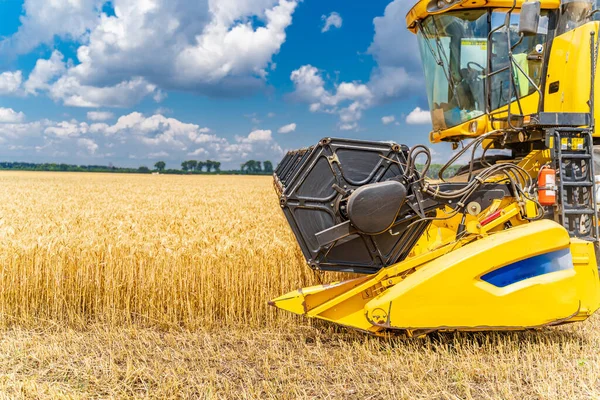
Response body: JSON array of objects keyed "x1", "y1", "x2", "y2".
[{"x1": 0, "y1": 318, "x2": 600, "y2": 400}]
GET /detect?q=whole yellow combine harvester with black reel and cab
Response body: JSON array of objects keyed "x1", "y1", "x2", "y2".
[{"x1": 271, "y1": 0, "x2": 600, "y2": 335}]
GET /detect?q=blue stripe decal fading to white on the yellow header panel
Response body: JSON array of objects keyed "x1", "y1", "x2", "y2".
[{"x1": 481, "y1": 249, "x2": 573, "y2": 287}]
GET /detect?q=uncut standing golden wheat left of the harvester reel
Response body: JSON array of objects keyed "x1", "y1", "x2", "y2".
[{"x1": 0, "y1": 172, "x2": 332, "y2": 329}]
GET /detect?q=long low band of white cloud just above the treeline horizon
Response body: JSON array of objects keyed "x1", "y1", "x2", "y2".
[{"x1": 0, "y1": 112, "x2": 284, "y2": 168}]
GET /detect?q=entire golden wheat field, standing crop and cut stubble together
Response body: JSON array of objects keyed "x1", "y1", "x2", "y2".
[{"x1": 0, "y1": 172, "x2": 600, "y2": 400}]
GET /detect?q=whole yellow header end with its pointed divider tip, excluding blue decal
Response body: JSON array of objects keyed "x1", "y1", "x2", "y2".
[{"x1": 272, "y1": 220, "x2": 600, "y2": 334}]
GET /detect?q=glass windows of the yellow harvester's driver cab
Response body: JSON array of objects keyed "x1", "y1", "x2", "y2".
[{"x1": 418, "y1": 9, "x2": 548, "y2": 130}]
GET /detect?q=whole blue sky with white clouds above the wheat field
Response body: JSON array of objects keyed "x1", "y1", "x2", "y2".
[{"x1": 0, "y1": 0, "x2": 440, "y2": 168}]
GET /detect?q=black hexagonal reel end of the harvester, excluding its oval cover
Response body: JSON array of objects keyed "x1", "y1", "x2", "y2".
[{"x1": 274, "y1": 139, "x2": 428, "y2": 273}]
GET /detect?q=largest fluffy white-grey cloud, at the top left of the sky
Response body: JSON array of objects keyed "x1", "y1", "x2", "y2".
[{"x1": 0, "y1": 0, "x2": 298, "y2": 107}]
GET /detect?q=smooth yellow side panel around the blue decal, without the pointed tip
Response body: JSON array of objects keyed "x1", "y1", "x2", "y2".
[{"x1": 365, "y1": 221, "x2": 599, "y2": 329}]
